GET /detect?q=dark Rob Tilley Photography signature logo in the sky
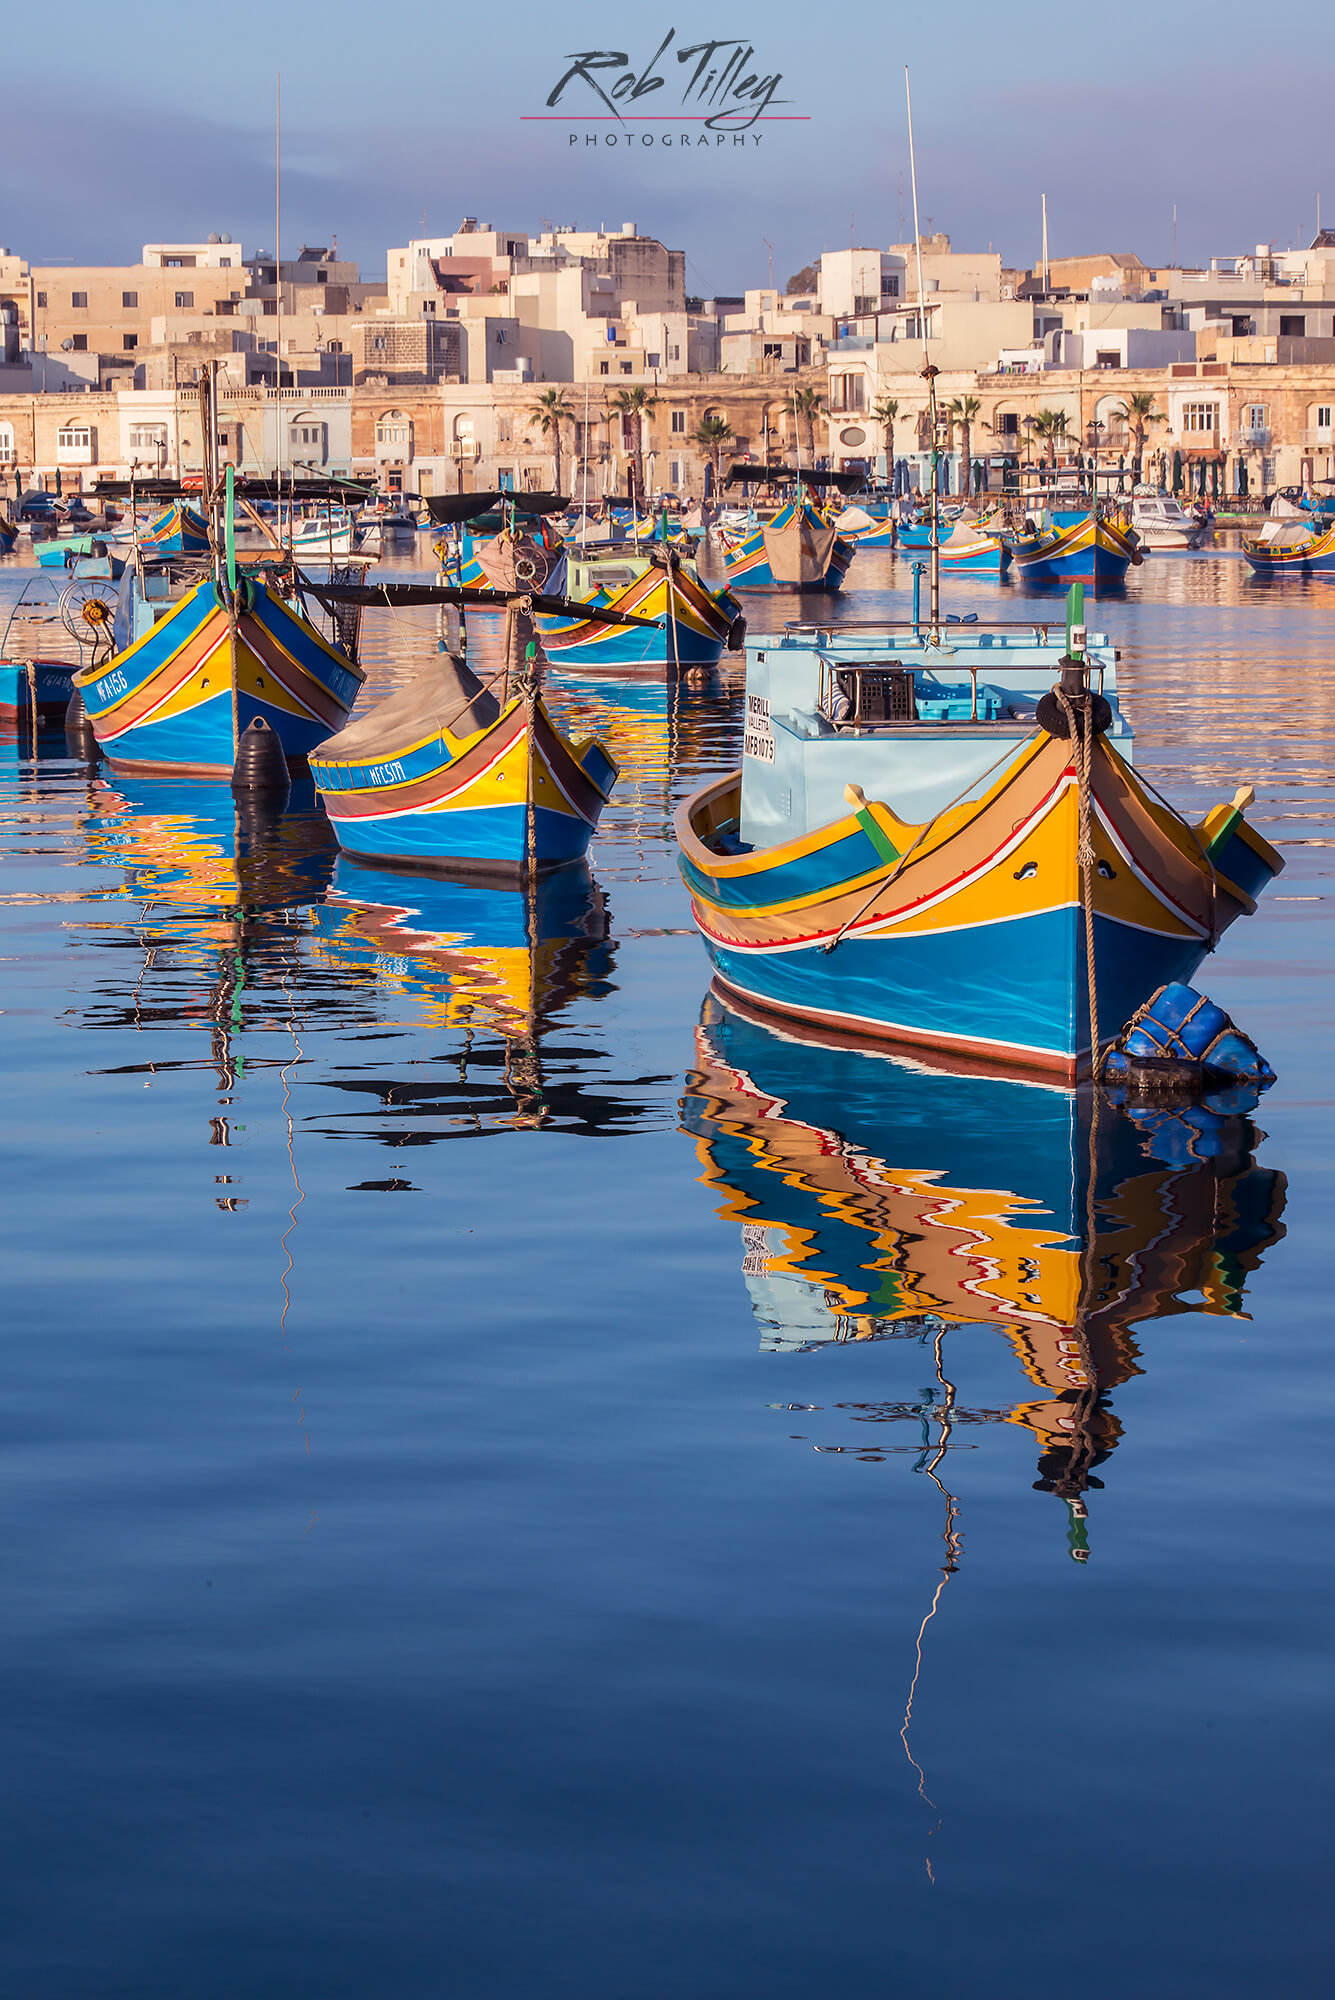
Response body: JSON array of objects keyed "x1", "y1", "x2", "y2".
[{"x1": 522, "y1": 28, "x2": 807, "y2": 148}]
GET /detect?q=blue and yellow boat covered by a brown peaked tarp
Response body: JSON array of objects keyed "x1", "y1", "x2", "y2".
[{"x1": 310, "y1": 654, "x2": 618, "y2": 874}]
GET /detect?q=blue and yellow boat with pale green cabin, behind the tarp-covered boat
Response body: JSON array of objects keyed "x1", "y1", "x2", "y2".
[{"x1": 538, "y1": 540, "x2": 745, "y2": 674}]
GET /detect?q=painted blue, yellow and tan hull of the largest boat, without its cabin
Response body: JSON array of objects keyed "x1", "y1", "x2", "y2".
[{"x1": 677, "y1": 732, "x2": 1283, "y2": 1082}]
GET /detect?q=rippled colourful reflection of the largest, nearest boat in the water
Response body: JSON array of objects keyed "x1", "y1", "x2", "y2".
[{"x1": 681, "y1": 994, "x2": 1285, "y2": 1528}]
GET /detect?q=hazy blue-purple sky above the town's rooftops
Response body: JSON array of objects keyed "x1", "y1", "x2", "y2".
[{"x1": 10, "y1": 0, "x2": 1335, "y2": 296}]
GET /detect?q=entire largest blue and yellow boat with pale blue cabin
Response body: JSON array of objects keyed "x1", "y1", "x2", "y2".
[{"x1": 677, "y1": 626, "x2": 1283, "y2": 1080}]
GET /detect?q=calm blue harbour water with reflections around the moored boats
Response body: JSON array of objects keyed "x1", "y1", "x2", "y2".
[{"x1": 0, "y1": 550, "x2": 1335, "y2": 2000}]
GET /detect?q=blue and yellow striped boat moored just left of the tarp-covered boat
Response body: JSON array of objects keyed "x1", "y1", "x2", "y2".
[{"x1": 74, "y1": 558, "x2": 364, "y2": 778}]
